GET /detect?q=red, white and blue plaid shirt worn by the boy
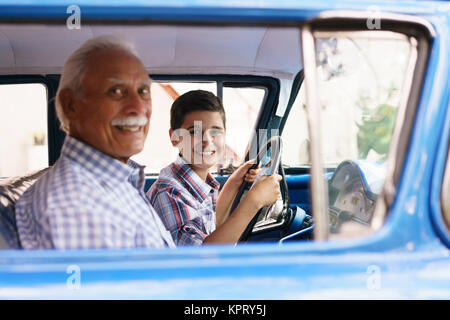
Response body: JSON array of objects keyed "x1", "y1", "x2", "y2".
[{"x1": 147, "y1": 157, "x2": 219, "y2": 245}]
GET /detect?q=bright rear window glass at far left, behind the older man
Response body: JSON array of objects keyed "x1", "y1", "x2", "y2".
[{"x1": 0, "y1": 83, "x2": 48, "y2": 177}]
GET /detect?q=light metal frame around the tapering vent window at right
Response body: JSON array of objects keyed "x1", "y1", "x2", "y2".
[{"x1": 301, "y1": 11, "x2": 435, "y2": 241}]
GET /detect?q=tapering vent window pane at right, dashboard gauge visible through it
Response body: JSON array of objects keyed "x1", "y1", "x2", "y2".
[{"x1": 300, "y1": 31, "x2": 415, "y2": 239}]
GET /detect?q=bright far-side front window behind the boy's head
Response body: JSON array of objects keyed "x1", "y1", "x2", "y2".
[{"x1": 132, "y1": 81, "x2": 265, "y2": 174}]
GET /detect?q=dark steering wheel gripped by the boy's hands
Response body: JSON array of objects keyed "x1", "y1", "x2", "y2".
[{"x1": 230, "y1": 136, "x2": 289, "y2": 242}]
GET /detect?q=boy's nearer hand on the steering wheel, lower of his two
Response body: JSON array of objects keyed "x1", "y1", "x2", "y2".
[{"x1": 246, "y1": 174, "x2": 281, "y2": 210}]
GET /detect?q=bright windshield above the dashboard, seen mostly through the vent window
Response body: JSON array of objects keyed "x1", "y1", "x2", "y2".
[{"x1": 282, "y1": 37, "x2": 410, "y2": 167}]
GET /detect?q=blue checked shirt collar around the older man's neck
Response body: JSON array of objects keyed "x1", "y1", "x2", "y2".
[{"x1": 61, "y1": 136, "x2": 145, "y2": 188}]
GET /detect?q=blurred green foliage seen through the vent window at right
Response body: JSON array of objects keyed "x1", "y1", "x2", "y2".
[{"x1": 357, "y1": 104, "x2": 397, "y2": 160}]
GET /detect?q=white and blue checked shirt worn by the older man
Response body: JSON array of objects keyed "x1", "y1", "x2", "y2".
[{"x1": 16, "y1": 136, "x2": 174, "y2": 249}]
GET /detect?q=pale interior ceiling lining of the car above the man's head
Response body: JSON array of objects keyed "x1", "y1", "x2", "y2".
[{"x1": 0, "y1": 24, "x2": 301, "y2": 79}]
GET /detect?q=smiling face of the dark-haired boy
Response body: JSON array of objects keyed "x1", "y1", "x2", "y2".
[{"x1": 170, "y1": 111, "x2": 225, "y2": 171}]
